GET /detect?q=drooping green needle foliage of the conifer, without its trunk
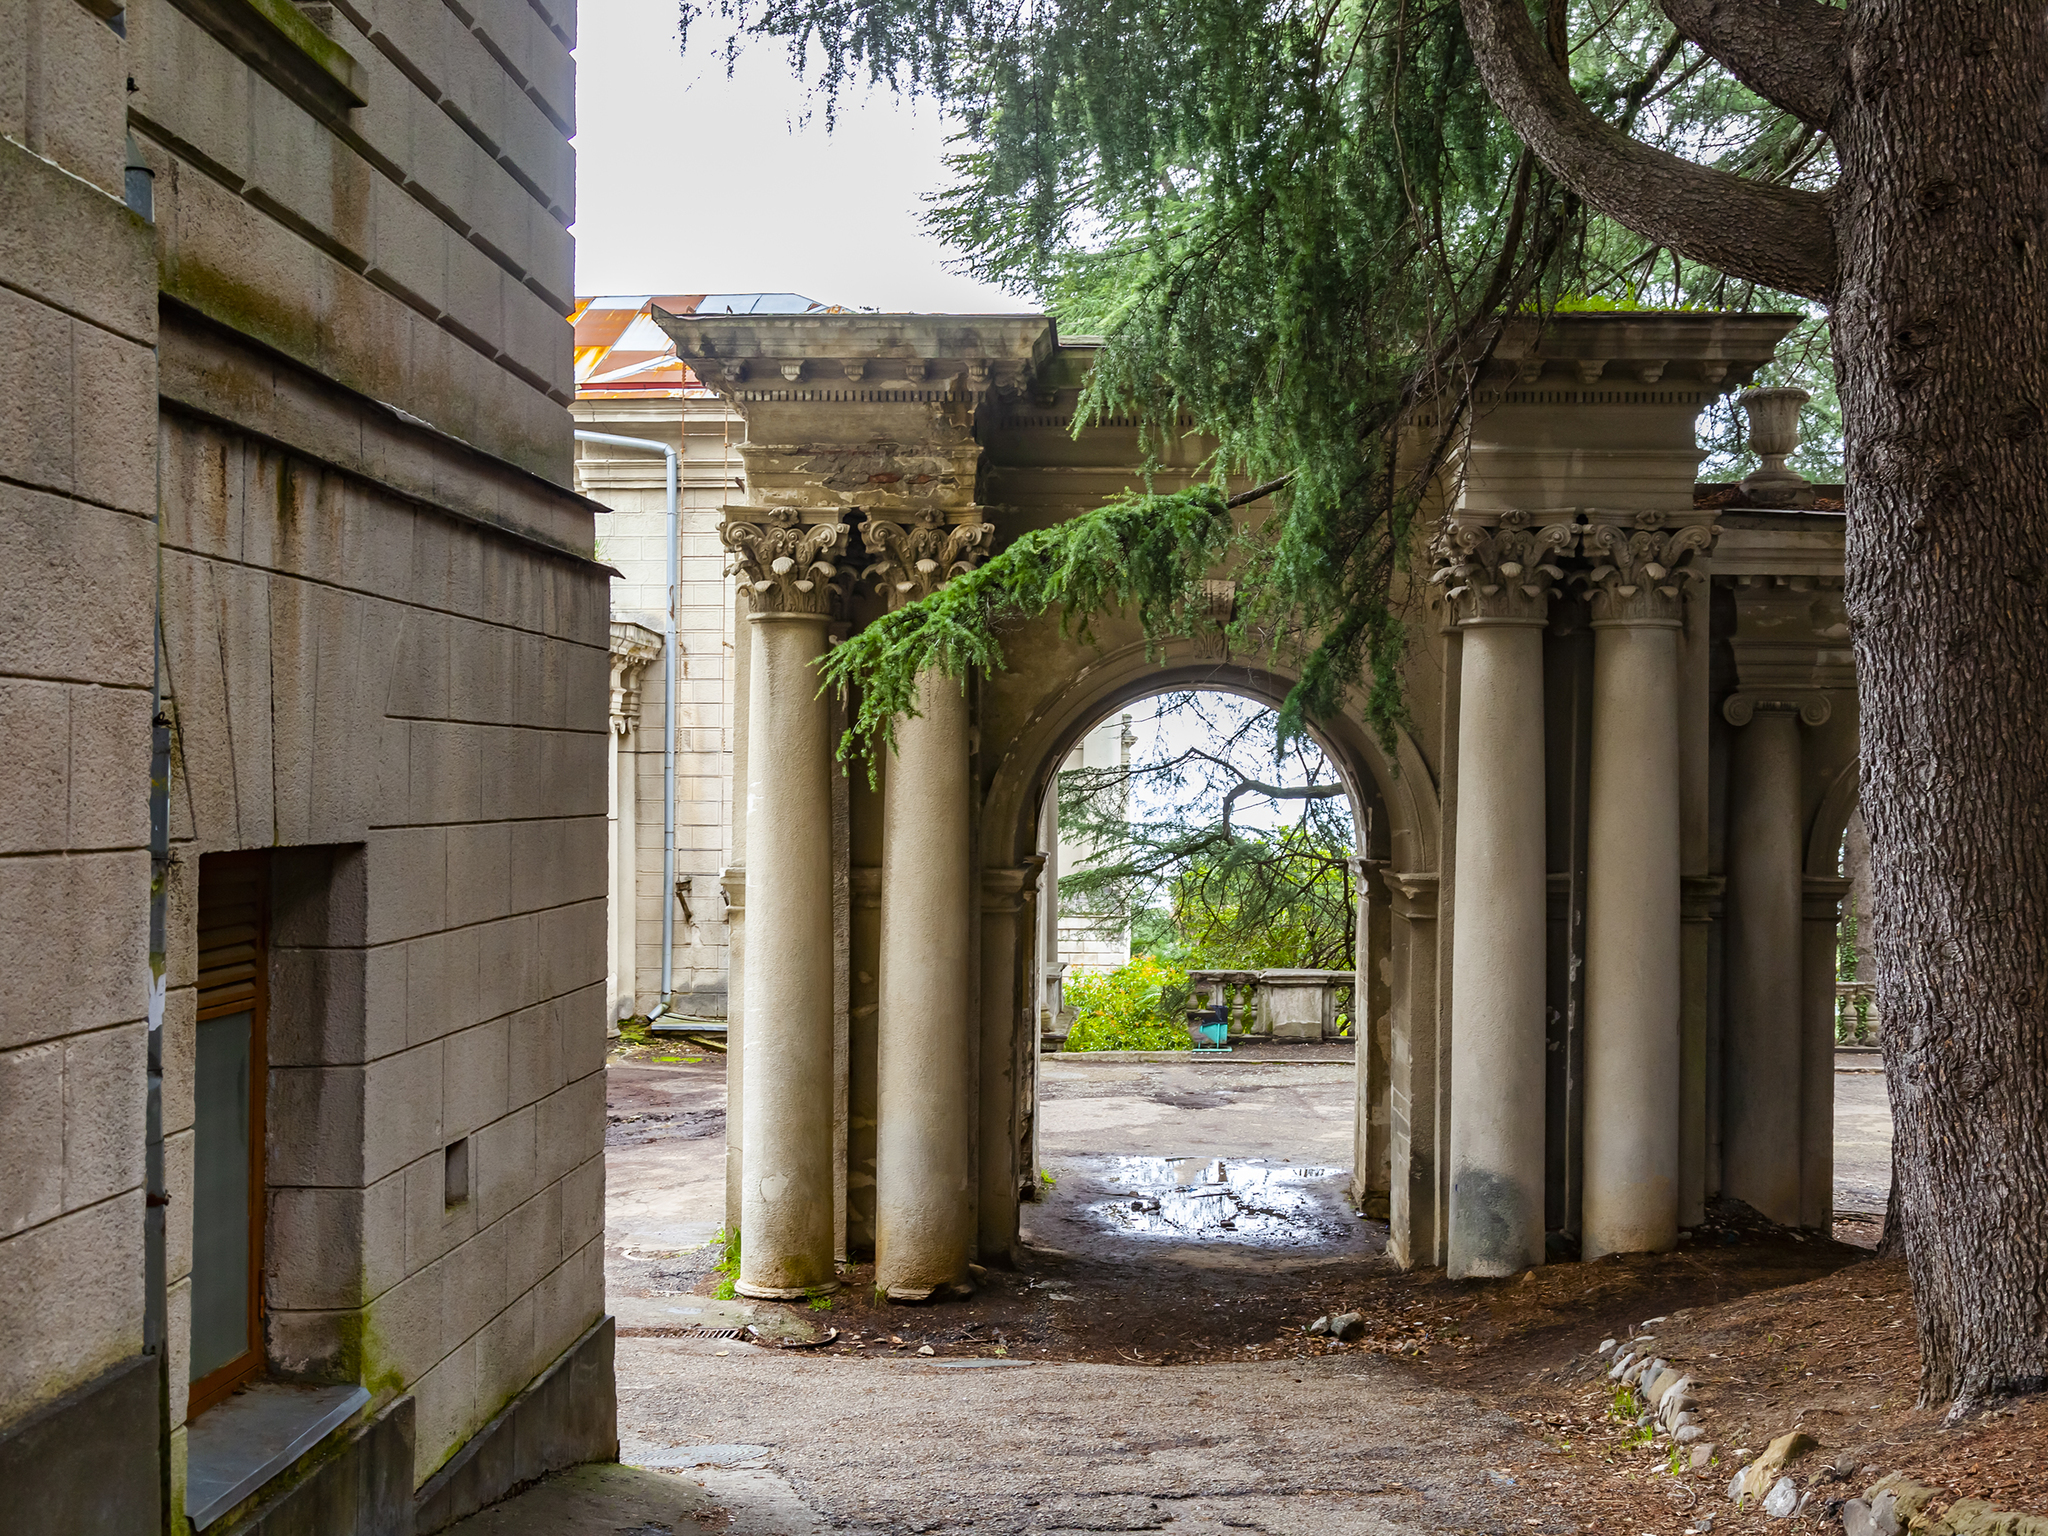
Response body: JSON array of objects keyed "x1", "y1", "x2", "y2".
[{"x1": 682, "y1": 0, "x2": 1833, "y2": 750}]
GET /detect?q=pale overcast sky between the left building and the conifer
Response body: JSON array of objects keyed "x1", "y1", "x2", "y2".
[{"x1": 575, "y1": 0, "x2": 1030, "y2": 311}]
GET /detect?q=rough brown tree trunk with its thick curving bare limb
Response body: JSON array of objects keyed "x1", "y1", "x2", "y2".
[{"x1": 1464, "y1": 0, "x2": 2048, "y2": 1413}]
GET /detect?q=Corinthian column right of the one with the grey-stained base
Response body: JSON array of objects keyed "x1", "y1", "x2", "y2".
[{"x1": 1581, "y1": 512, "x2": 1714, "y2": 1260}]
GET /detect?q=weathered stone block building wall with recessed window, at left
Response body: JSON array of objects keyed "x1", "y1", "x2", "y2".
[{"x1": 0, "y1": 0, "x2": 614, "y2": 1532}]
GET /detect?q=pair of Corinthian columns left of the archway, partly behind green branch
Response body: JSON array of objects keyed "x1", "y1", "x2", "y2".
[{"x1": 721, "y1": 510, "x2": 999, "y2": 1300}]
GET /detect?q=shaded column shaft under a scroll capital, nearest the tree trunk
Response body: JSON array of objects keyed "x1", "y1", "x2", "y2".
[{"x1": 1720, "y1": 711, "x2": 1802, "y2": 1227}]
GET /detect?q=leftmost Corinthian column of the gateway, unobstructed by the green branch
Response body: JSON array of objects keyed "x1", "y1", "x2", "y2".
[{"x1": 719, "y1": 510, "x2": 846, "y2": 1298}]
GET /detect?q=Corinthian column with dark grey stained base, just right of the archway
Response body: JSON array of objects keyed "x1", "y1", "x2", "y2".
[{"x1": 1433, "y1": 512, "x2": 1573, "y2": 1280}]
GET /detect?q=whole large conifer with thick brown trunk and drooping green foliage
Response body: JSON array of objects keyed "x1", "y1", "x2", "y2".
[{"x1": 684, "y1": 0, "x2": 2048, "y2": 1409}]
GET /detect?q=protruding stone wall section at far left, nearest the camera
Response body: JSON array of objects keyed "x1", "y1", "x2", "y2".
[{"x1": 0, "y1": 0, "x2": 160, "y2": 1530}]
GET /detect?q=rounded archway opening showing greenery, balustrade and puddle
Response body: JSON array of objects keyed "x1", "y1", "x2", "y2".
[{"x1": 1020, "y1": 686, "x2": 1386, "y2": 1310}]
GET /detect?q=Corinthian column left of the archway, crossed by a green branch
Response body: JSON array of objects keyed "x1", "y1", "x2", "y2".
[{"x1": 860, "y1": 512, "x2": 995, "y2": 1300}]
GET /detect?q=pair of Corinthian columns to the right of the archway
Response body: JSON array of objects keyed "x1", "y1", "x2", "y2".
[{"x1": 1438, "y1": 512, "x2": 1712, "y2": 1276}]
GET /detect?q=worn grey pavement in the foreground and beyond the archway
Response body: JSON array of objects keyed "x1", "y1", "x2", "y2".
[{"x1": 455, "y1": 1059, "x2": 1888, "y2": 1536}]
